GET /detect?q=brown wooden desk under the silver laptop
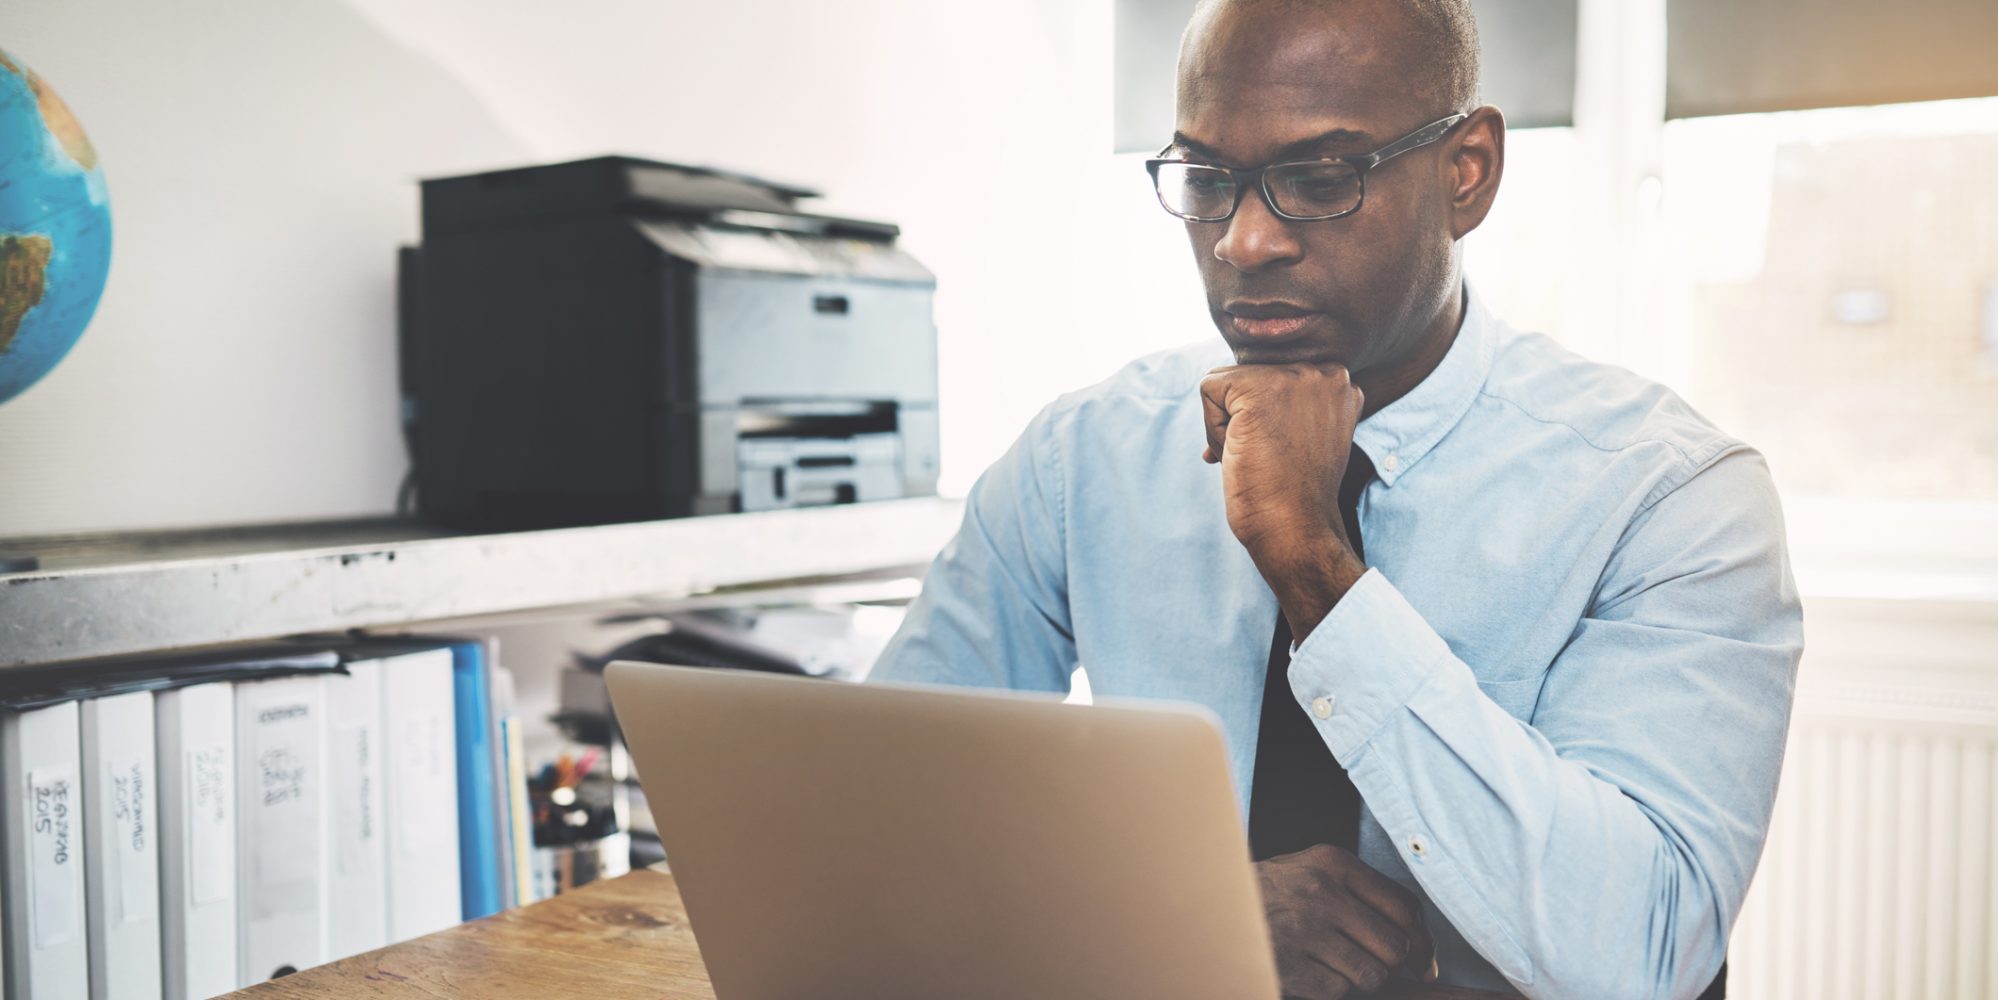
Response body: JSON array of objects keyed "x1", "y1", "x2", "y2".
[{"x1": 230, "y1": 870, "x2": 1497, "y2": 1000}]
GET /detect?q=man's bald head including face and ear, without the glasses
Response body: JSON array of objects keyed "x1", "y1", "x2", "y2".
[{"x1": 1161, "y1": 0, "x2": 1504, "y2": 385}]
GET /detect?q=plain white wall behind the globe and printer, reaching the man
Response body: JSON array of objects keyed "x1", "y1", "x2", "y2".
[{"x1": 0, "y1": 0, "x2": 1215, "y2": 537}]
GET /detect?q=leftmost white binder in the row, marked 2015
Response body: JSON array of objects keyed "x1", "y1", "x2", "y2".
[{"x1": 0, "y1": 701, "x2": 90, "y2": 1000}]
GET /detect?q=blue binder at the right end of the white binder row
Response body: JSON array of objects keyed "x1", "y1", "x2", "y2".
[{"x1": 452, "y1": 641, "x2": 505, "y2": 920}]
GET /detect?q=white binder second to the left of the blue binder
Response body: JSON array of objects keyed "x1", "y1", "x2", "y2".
[{"x1": 326, "y1": 661, "x2": 388, "y2": 960}]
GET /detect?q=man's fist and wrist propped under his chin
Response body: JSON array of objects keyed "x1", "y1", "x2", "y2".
[{"x1": 1201, "y1": 365, "x2": 1367, "y2": 643}]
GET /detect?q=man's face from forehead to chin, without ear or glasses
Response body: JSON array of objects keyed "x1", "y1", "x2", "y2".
[{"x1": 1167, "y1": 0, "x2": 1459, "y2": 373}]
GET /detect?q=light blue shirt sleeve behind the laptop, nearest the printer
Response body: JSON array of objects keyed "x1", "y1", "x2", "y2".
[{"x1": 867, "y1": 407, "x2": 1075, "y2": 693}]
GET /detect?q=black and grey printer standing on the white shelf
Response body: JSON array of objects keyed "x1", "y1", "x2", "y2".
[{"x1": 402, "y1": 156, "x2": 937, "y2": 531}]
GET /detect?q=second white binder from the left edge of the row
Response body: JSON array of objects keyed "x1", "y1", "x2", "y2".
[{"x1": 82, "y1": 691, "x2": 160, "y2": 1000}]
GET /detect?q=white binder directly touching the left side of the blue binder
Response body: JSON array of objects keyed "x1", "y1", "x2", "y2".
[{"x1": 382, "y1": 649, "x2": 462, "y2": 940}]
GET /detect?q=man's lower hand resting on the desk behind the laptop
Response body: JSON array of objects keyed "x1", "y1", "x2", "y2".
[{"x1": 1255, "y1": 844, "x2": 1437, "y2": 1000}]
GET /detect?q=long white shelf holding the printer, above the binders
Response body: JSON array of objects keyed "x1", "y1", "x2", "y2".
[{"x1": 0, "y1": 497, "x2": 963, "y2": 667}]
